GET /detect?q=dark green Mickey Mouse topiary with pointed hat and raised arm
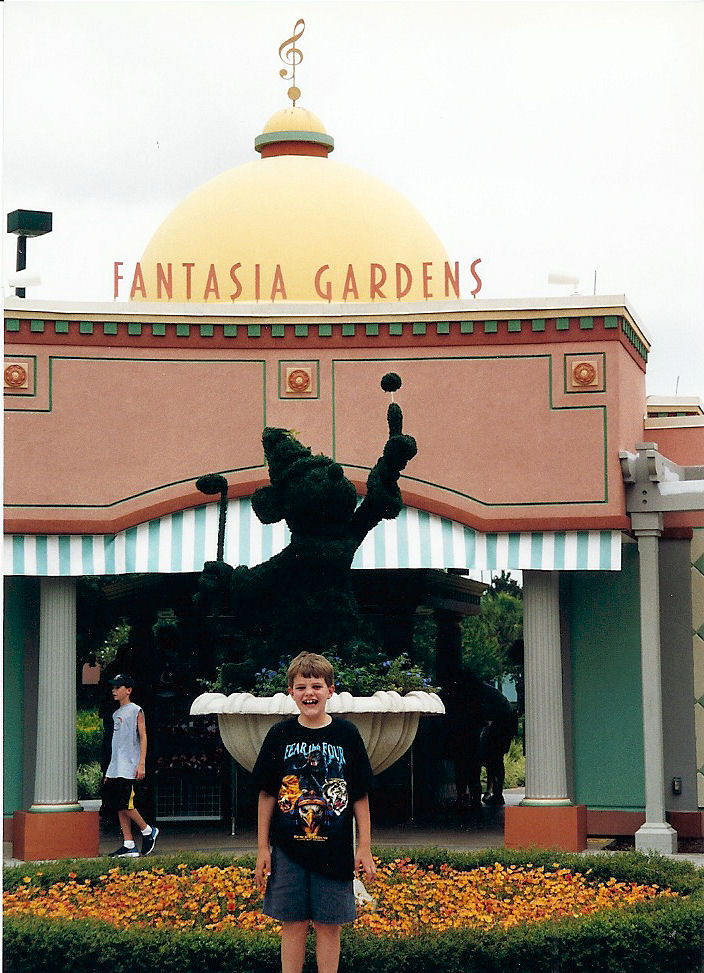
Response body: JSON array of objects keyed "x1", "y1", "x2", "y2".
[{"x1": 199, "y1": 373, "x2": 417, "y2": 689}]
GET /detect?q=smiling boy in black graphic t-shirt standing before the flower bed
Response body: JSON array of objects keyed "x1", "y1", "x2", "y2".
[{"x1": 253, "y1": 652, "x2": 376, "y2": 973}]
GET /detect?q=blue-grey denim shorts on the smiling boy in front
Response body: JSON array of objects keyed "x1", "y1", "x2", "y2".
[{"x1": 262, "y1": 846, "x2": 357, "y2": 925}]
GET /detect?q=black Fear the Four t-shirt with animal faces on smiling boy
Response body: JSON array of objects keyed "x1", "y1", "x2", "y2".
[{"x1": 252, "y1": 717, "x2": 372, "y2": 879}]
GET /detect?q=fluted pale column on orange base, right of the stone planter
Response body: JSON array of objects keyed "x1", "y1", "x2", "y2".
[{"x1": 522, "y1": 571, "x2": 572, "y2": 807}]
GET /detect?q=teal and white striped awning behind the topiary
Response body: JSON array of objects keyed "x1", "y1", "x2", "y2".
[{"x1": 4, "y1": 498, "x2": 621, "y2": 577}]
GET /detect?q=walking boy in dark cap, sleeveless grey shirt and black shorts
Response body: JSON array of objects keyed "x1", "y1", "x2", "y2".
[{"x1": 103, "y1": 672, "x2": 159, "y2": 858}]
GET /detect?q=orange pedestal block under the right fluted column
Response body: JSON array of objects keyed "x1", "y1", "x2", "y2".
[{"x1": 504, "y1": 804, "x2": 587, "y2": 851}]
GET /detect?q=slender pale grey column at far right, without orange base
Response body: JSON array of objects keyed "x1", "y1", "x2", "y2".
[{"x1": 631, "y1": 513, "x2": 677, "y2": 855}]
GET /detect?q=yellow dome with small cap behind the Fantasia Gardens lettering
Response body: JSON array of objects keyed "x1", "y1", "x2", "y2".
[{"x1": 132, "y1": 108, "x2": 457, "y2": 303}]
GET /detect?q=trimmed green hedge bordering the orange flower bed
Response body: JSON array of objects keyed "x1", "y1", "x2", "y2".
[{"x1": 4, "y1": 848, "x2": 704, "y2": 973}]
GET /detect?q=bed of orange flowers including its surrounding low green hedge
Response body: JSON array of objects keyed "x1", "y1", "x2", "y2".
[{"x1": 4, "y1": 850, "x2": 704, "y2": 973}]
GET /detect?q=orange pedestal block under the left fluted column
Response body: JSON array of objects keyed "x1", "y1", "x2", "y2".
[{"x1": 12, "y1": 811, "x2": 100, "y2": 861}]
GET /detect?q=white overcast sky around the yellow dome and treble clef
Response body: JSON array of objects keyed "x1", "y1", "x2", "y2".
[{"x1": 2, "y1": 0, "x2": 704, "y2": 398}]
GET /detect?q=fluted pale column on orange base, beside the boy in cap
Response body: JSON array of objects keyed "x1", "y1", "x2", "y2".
[{"x1": 30, "y1": 578, "x2": 83, "y2": 812}]
